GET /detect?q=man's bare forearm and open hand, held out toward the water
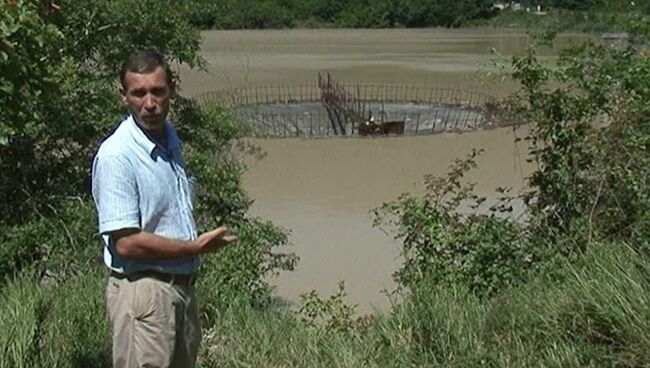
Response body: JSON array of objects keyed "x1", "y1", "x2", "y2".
[{"x1": 109, "y1": 226, "x2": 237, "y2": 259}]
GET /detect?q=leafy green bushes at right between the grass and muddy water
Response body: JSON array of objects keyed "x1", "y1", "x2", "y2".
[{"x1": 375, "y1": 20, "x2": 650, "y2": 295}]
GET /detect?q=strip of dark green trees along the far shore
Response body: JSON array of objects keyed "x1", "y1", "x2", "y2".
[{"x1": 189, "y1": 0, "x2": 650, "y2": 32}]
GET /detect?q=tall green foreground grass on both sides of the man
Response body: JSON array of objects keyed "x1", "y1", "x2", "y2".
[{"x1": 0, "y1": 244, "x2": 650, "y2": 367}]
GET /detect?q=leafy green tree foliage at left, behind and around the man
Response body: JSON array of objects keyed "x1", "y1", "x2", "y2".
[{"x1": 0, "y1": 0, "x2": 295, "y2": 303}]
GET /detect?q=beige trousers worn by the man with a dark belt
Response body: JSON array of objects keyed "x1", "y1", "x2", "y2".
[{"x1": 106, "y1": 277, "x2": 201, "y2": 368}]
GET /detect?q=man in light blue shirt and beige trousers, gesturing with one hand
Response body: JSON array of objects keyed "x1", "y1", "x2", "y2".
[{"x1": 92, "y1": 52, "x2": 236, "y2": 368}]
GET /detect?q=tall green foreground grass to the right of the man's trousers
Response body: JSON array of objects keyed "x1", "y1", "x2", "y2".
[{"x1": 195, "y1": 244, "x2": 650, "y2": 367}]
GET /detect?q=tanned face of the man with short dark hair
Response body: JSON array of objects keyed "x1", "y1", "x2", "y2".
[{"x1": 120, "y1": 67, "x2": 173, "y2": 131}]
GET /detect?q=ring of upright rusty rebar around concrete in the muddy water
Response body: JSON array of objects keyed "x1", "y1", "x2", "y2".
[{"x1": 195, "y1": 81, "x2": 493, "y2": 137}]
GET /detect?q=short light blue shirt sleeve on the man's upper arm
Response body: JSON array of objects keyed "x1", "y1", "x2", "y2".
[{"x1": 92, "y1": 156, "x2": 141, "y2": 234}]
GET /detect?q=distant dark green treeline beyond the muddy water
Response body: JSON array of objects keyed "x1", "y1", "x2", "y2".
[{"x1": 187, "y1": 0, "x2": 650, "y2": 29}]
